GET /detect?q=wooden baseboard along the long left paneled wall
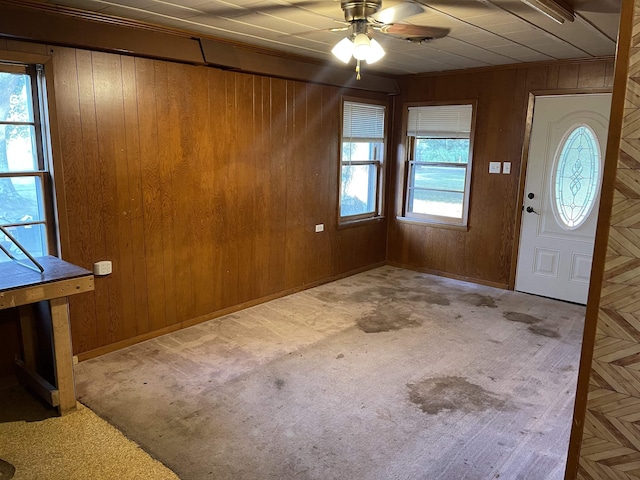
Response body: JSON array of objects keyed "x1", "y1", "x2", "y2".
[{"x1": 76, "y1": 262, "x2": 387, "y2": 362}]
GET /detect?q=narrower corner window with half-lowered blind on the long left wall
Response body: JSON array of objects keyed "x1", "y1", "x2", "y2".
[{"x1": 340, "y1": 101, "x2": 385, "y2": 222}]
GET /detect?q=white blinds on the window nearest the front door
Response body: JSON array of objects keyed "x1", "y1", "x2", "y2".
[{"x1": 407, "y1": 105, "x2": 473, "y2": 138}]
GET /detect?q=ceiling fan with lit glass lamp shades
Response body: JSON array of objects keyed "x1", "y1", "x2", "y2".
[{"x1": 331, "y1": 0, "x2": 449, "y2": 80}]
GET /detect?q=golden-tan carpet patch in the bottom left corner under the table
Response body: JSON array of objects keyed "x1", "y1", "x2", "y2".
[{"x1": 0, "y1": 392, "x2": 178, "y2": 480}]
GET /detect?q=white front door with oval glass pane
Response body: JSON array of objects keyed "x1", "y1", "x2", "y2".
[{"x1": 515, "y1": 94, "x2": 611, "y2": 304}]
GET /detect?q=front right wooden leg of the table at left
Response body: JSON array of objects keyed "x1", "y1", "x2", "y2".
[{"x1": 49, "y1": 297, "x2": 76, "y2": 415}]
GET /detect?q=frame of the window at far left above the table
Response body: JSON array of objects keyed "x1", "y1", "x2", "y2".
[{"x1": 0, "y1": 62, "x2": 59, "y2": 261}]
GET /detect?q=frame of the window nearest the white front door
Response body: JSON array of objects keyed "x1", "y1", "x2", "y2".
[{"x1": 398, "y1": 99, "x2": 477, "y2": 230}]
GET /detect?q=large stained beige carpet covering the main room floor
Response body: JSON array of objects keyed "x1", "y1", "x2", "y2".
[{"x1": 76, "y1": 267, "x2": 584, "y2": 480}]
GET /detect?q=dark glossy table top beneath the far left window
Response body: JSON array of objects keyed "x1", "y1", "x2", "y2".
[{"x1": 0, "y1": 256, "x2": 93, "y2": 292}]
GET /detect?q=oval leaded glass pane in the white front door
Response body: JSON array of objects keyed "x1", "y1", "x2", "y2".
[{"x1": 554, "y1": 125, "x2": 600, "y2": 230}]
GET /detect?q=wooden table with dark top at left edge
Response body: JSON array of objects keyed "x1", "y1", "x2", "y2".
[{"x1": 0, "y1": 256, "x2": 93, "y2": 415}]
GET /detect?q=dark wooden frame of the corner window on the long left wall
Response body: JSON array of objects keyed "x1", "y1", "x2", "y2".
[{"x1": 337, "y1": 95, "x2": 389, "y2": 226}]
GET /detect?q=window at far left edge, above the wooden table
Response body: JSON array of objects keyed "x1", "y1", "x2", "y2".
[{"x1": 0, "y1": 63, "x2": 54, "y2": 261}]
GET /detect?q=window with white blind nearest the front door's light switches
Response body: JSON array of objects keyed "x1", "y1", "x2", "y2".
[{"x1": 404, "y1": 104, "x2": 473, "y2": 226}]
